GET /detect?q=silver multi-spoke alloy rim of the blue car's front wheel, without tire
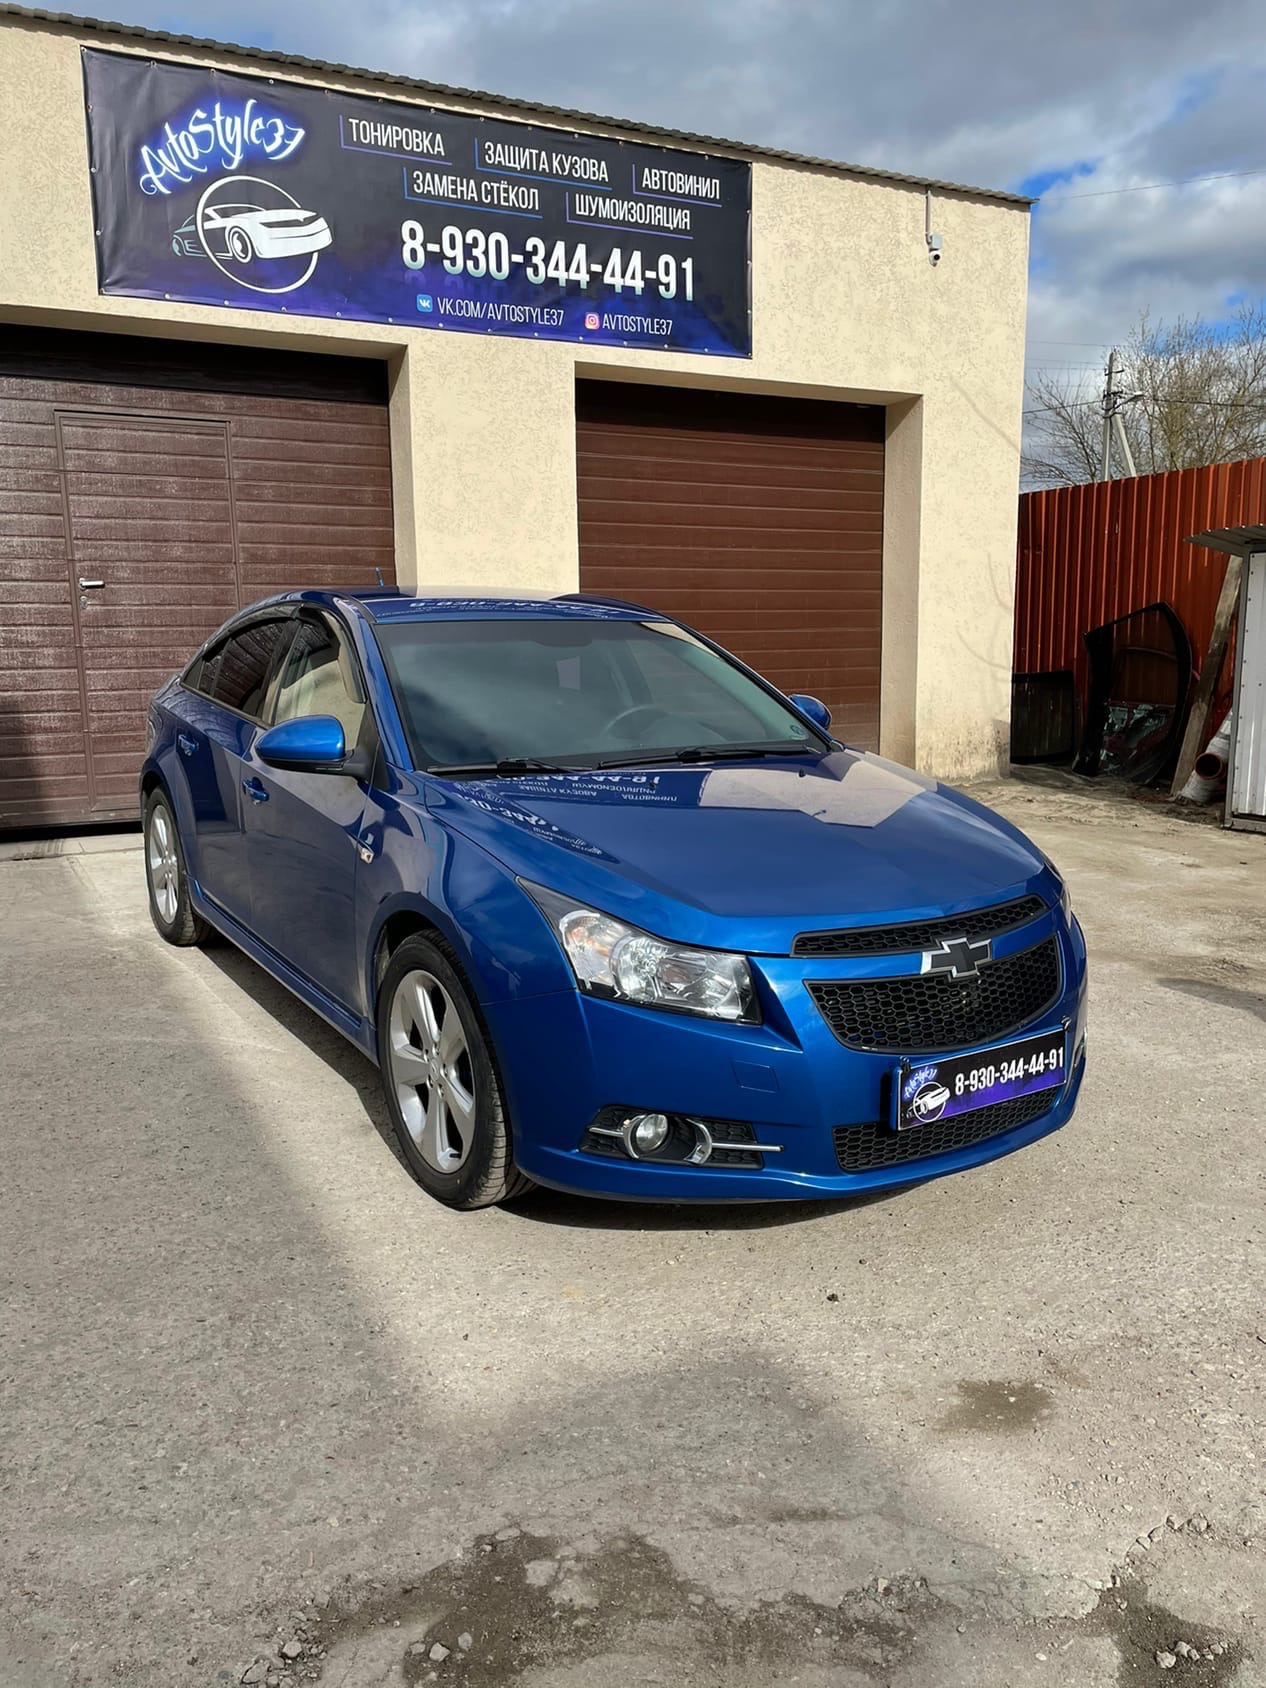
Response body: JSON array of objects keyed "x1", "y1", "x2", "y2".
[{"x1": 388, "y1": 969, "x2": 474, "y2": 1173}]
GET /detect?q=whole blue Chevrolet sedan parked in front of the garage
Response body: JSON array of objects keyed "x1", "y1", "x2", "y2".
[{"x1": 142, "y1": 591, "x2": 1085, "y2": 1209}]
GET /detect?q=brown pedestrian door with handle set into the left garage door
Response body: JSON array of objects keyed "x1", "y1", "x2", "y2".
[{"x1": 57, "y1": 410, "x2": 238, "y2": 815}]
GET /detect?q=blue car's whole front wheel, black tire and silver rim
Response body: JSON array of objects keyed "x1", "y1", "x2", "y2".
[{"x1": 378, "y1": 935, "x2": 532, "y2": 1210}]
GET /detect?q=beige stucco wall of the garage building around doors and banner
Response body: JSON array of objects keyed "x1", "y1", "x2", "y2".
[{"x1": 0, "y1": 19, "x2": 1028, "y2": 778}]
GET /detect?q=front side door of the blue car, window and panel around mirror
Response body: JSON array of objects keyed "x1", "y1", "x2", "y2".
[{"x1": 243, "y1": 611, "x2": 376, "y2": 1013}]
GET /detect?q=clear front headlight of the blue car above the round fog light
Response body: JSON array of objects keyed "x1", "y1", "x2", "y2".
[{"x1": 520, "y1": 879, "x2": 760, "y2": 1025}]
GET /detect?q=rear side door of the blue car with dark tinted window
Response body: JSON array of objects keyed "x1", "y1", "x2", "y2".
[{"x1": 176, "y1": 616, "x2": 294, "y2": 927}]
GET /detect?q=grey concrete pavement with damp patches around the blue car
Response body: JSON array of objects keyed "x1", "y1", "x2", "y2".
[{"x1": 0, "y1": 783, "x2": 1266, "y2": 1688}]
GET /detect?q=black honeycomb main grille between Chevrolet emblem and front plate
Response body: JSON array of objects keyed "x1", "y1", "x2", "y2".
[{"x1": 809, "y1": 937, "x2": 1062, "y2": 1055}]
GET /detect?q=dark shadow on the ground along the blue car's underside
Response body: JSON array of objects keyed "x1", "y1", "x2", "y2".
[{"x1": 203, "y1": 939, "x2": 917, "y2": 1231}]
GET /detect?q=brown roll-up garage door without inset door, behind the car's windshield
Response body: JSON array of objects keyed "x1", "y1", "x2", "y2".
[{"x1": 576, "y1": 381, "x2": 885, "y2": 749}]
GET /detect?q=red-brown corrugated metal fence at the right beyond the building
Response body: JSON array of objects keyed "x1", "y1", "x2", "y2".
[{"x1": 1014, "y1": 457, "x2": 1266, "y2": 690}]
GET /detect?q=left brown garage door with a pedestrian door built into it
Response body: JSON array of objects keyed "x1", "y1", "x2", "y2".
[{"x1": 0, "y1": 333, "x2": 395, "y2": 829}]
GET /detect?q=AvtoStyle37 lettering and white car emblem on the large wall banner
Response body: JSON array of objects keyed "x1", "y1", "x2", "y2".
[{"x1": 137, "y1": 98, "x2": 334, "y2": 294}]
